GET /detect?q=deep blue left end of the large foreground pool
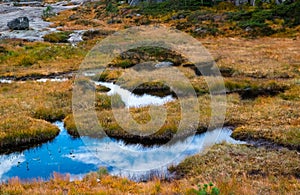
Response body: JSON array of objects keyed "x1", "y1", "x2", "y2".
[{"x1": 0, "y1": 122, "x2": 102, "y2": 180}]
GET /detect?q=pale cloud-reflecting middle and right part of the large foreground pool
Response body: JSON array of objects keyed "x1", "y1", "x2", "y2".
[{"x1": 67, "y1": 128, "x2": 244, "y2": 176}]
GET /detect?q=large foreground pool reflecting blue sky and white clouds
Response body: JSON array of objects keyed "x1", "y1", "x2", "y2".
[{"x1": 0, "y1": 122, "x2": 244, "y2": 181}]
